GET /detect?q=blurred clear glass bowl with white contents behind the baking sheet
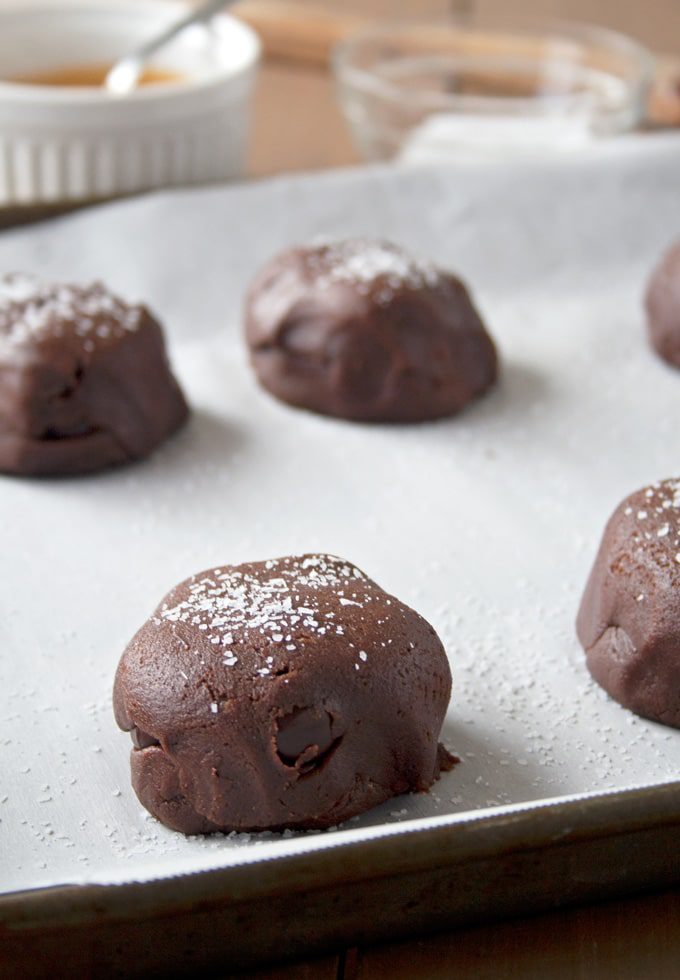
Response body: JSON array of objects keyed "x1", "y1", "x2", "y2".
[{"x1": 333, "y1": 22, "x2": 654, "y2": 162}]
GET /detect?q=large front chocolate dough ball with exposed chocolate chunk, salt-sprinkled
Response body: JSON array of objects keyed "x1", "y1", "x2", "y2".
[{"x1": 114, "y1": 555, "x2": 451, "y2": 834}]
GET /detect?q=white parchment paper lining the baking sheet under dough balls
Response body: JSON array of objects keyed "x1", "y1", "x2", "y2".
[{"x1": 0, "y1": 137, "x2": 680, "y2": 891}]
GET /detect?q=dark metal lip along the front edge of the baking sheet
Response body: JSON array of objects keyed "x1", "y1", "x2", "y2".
[{"x1": 0, "y1": 780, "x2": 680, "y2": 929}]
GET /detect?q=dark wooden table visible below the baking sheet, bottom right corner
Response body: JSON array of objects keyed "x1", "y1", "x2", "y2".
[{"x1": 236, "y1": 889, "x2": 680, "y2": 980}]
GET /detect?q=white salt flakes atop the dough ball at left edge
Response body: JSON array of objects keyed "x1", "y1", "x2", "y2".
[{"x1": 0, "y1": 274, "x2": 142, "y2": 349}]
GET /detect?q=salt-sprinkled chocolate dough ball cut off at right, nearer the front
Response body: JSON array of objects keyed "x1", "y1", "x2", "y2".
[{"x1": 577, "y1": 480, "x2": 680, "y2": 728}]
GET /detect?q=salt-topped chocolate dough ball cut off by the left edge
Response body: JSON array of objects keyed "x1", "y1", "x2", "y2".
[{"x1": 0, "y1": 276, "x2": 188, "y2": 476}]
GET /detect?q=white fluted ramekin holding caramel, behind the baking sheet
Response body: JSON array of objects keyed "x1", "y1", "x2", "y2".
[{"x1": 0, "y1": 0, "x2": 260, "y2": 207}]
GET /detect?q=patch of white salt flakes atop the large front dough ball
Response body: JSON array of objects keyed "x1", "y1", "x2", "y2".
[{"x1": 155, "y1": 555, "x2": 378, "y2": 666}]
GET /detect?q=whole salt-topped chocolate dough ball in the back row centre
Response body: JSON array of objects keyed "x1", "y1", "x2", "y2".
[{"x1": 246, "y1": 240, "x2": 497, "y2": 422}]
